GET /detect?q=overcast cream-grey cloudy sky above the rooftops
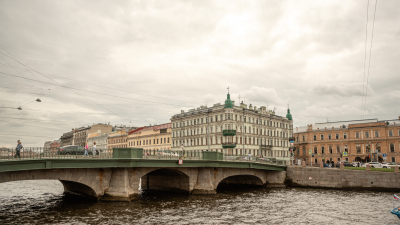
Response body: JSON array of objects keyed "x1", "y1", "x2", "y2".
[{"x1": 0, "y1": 0, "x2": 400, "y2": 147}]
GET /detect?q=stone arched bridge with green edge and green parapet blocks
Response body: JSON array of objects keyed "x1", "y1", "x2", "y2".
[{"x1": 0, "y1": 148, "x2": 286, "y2": 201}]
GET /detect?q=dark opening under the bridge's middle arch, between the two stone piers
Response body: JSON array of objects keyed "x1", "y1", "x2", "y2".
[{"x1": 141, "y1": 168, "x2": 190, "y2": 194}]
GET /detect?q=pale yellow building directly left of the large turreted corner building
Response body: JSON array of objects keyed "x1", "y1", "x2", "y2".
[{"x1": 128, "y1": 123, "x2": 171, "y2": 155}]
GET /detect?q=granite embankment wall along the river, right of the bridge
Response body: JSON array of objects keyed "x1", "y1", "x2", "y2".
[{"x1": 285, "y1": 166, "x2": 400, "y2": 191}]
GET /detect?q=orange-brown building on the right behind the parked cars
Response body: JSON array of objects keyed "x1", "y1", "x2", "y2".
[{"x1": 294, "y1": 118, "x2": 400, "y2": 164}]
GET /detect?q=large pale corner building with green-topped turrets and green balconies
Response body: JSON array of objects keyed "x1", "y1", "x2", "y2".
[{"x1": 171, "y1": 93, "x2": 293, "y2": 157}]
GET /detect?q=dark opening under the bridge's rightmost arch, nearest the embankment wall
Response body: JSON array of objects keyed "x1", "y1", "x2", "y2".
[{"x1": 217, "y1": 175, "x2": 264, "y2": 190}]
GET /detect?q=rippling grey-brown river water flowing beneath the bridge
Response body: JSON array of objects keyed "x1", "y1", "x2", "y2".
[{"x1": 0, "y1": 180, "x2": 400, "y2": 225}]
